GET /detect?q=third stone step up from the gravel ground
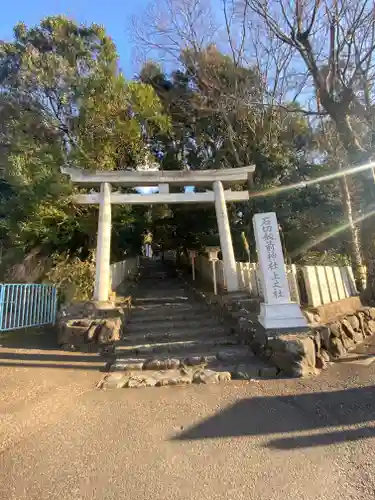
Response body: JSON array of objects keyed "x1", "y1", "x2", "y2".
[{"x1": 115, "y1": 336, "x2": 238, "y2": 357}]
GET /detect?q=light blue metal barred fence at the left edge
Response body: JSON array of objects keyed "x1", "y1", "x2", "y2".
[{"x1": 0, "y1": 284, "x2": 57, "y2": 332}]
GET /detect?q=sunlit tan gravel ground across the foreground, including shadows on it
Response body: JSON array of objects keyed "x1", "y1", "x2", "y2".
[{"x1": 0, "y1": 336, "x2": 375, "y2": 500}]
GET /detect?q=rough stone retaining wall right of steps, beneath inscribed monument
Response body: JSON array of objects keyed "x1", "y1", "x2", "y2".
[{"x1": 178, "y1": 266, "x2": 375, "y2": 377}]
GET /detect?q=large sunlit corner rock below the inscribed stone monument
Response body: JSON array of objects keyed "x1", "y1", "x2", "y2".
[{"x1": 268, "y1": 334, "x2": 316, "y2": 377}]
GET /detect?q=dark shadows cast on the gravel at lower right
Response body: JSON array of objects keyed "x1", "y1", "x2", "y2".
[{"x1": 172, "y1": 386, "x2": 375, "y2": 450}]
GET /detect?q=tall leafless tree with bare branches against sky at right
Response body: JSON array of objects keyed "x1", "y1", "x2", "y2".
[{"x1": 243, "y1": 0, "x2": 375, "y2": 299}]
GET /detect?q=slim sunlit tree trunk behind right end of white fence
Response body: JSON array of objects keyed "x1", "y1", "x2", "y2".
[{"x1": 340, "y1": 175, "x2": 366, "y2": 292}]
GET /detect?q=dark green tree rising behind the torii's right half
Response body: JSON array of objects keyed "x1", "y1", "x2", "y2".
[{"x1": 140, "y1": 46, "x2": 342, "y2": 258}]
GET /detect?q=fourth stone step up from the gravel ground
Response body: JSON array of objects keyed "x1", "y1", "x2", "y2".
[{"x1": 121, "y1": 325, "x2": 230, "y2": 345}]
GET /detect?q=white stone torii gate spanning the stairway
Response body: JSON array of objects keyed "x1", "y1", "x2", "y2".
[{"x1": 61, "y1": 165, "x2": 255, "y2": 302}]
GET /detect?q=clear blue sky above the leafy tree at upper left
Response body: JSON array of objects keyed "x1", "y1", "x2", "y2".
[{"x1": 0, "y1": 0, "x2": 150, "y2": 78}]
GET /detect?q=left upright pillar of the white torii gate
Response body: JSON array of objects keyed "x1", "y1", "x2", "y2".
[{"x1": 94, "y1": 182, "x2": 112, "y2": 302}]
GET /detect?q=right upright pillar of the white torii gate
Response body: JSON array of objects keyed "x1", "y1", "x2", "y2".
[{"x1": 213, "y1": 181, "x2": 238, "y2": 292}]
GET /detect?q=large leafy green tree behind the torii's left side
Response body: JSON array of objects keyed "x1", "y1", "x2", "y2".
[{"x1": 0, "y1": 16, "x2": 169, "y2": 282}]
